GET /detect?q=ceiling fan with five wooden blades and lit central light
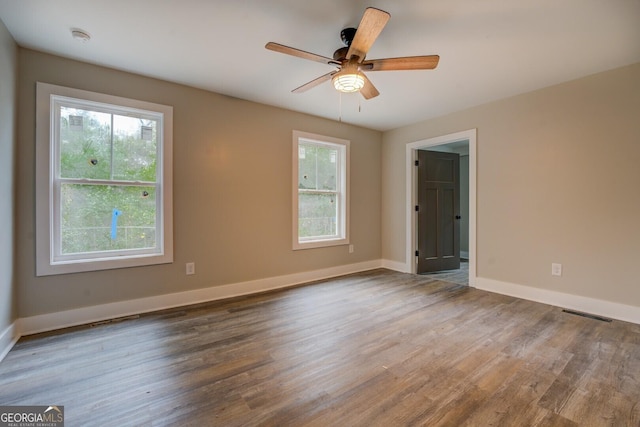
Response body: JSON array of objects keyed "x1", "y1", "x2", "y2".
[{"x1": 265, "y1": 7, "x2": 440, "y2": 99}]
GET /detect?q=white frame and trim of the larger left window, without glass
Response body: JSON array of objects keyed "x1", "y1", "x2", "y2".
[{"x1": 36, "y1": 82, "x2": 173, "y2": 276}]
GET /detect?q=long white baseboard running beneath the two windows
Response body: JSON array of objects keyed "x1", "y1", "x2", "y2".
[{"x1": 18, "y1": 260, "x2": 382, "y2": 335}]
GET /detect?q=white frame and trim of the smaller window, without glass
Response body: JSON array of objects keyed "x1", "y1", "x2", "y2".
[{"x1": 292, "y1": 130, "x2": 351, "y2": 250}]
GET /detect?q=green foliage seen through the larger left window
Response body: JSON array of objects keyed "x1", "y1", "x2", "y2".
[{"x1": 57, "y1": 102, "x2": 158, "y2": 255}]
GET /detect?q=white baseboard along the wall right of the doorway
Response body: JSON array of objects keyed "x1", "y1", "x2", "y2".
[{"x1": 476, "y1": 277, "x2": 640, "y2": 324}]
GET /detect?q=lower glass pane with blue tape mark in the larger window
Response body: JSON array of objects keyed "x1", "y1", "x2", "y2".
[{"x1": 60, "y1": 184, "x2": 156, "y2": 255}]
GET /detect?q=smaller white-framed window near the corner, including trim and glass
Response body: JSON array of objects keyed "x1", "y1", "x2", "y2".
[{"x1": 293, "y1": 131, "x2": 349, "y2": 249}]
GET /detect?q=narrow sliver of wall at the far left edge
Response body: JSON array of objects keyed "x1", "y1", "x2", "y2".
[{"x1": 0, "y1": 21, "x2": 18, "y2": 334}]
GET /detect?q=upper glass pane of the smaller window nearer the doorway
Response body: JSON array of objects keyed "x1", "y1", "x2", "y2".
[{"x1": 298, "y1": 144, "x2": 338, "y2": 191}]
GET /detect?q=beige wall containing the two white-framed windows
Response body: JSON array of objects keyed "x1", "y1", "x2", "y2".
[{"x1": 17, "y1": 49, "x2": 382, "y2": 317}]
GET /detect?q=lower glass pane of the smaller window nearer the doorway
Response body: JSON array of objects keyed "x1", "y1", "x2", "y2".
[{"x1": 298, "y1": 193, "x2": 338, "y2": 240}]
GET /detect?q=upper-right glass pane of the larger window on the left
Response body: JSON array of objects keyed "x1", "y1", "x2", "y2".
[{"x1": 113, "y1": 115, "x2": 157, "y2": 182}]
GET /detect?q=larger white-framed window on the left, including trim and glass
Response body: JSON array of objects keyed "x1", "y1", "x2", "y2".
[{"x1": 36, "y1": 83, "x2": 173, "y2": 275}]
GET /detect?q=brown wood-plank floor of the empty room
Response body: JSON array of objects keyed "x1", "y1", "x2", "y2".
[{"x1": 0, "y1": 270, "x2": 640, "y2": 427}]
